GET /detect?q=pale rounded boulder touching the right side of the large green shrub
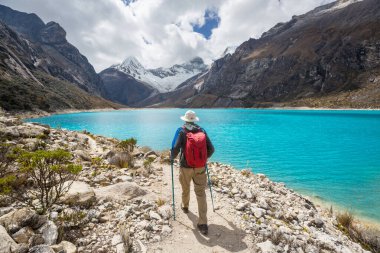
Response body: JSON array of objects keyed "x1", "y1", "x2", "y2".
[{"x1": 61, "y1": 181, "x2": 96, "y2": 207}]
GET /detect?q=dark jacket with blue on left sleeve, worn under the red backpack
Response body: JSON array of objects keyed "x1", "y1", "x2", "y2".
[{"x1": 172, "y1": 123, "x2": 214, "y2": 168}]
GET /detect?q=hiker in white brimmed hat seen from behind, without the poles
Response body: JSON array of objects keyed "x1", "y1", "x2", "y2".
[{"x1": 172, "y1": 110, "x2": 214, "y2": 235}]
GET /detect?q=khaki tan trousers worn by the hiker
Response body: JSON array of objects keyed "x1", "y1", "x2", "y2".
[{"x1": 179, "y1": 167, "x2": 207, "y2": 224}]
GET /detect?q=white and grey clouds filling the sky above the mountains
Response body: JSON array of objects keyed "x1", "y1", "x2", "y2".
[{"x1": 0, "y1": 0, "x2": 332, "y2": 71}]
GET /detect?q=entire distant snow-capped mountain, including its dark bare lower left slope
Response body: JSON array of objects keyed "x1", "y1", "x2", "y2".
[{"x1": 99, "y1": 57, "x2": 208, "y2": 106}]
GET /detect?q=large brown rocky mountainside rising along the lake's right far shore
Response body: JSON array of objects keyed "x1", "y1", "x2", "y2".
[{"x1": 142, "y1": 0, "x2": 380, "y2": 108}]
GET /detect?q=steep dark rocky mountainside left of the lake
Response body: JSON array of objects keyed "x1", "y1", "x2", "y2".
[{"x1": 0, "y1": 5, "x2": 119, "y2": 111}]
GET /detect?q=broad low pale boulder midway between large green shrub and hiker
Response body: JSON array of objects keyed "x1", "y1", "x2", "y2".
[{"x1": 95, "y1": 182, "x2": 146, "y2": 200}]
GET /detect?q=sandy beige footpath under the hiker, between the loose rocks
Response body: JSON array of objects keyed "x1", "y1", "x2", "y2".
[{"x1": 148, "y1": 162, "x2": 252, "y2": 253}]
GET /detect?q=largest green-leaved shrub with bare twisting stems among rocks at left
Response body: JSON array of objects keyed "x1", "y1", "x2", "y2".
[{"x1": 14, "y1": 149, "x2": 82, "y2": 213}]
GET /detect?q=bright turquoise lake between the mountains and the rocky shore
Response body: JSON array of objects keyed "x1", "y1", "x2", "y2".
[{"x1": 29, "y1": 109, "x2": 380, "y2": 221}]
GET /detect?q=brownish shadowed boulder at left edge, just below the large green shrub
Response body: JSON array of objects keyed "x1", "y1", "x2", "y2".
[{"x1": 0, "y1": 208, "x2": 47, "y2": 234}]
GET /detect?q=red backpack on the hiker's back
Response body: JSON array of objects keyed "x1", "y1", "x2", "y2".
[{"x1": 185, "y1": 130, "x2": 207, "y2": 168}]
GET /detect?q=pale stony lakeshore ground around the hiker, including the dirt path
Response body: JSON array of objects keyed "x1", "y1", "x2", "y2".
[{"x1": 0, "y1": 116, "x2": 379, "y2": 253}]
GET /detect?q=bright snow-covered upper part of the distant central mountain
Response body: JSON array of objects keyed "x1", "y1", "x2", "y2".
[{"x1": 111, "y1": 57, "x2": 208, "y2": 92}]
